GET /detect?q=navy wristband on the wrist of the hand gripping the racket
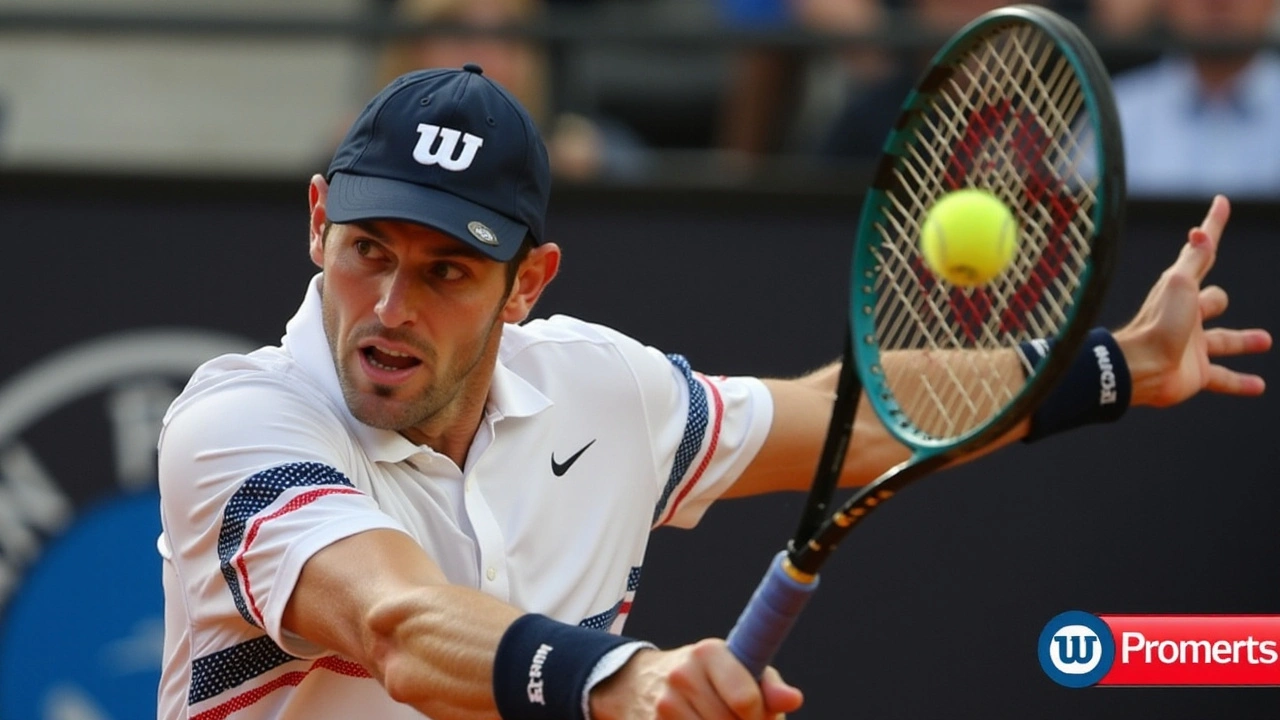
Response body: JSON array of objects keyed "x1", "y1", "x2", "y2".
[{"x1": 493, "y1": 614, "x2": 635, "y2": 720}]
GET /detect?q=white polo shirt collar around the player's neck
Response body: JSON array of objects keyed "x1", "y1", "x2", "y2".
[{"x1": 282, "y1": 273, "x2": 552, "y2": 462}]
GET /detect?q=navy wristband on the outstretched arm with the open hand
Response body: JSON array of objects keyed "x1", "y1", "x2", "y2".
[{"x1": 1018, "y1": 328, "x2": 1133, "y2": 442}]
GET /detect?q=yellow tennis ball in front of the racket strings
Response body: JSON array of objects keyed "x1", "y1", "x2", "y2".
[{"x1": 920, "y1": 188, "x2": 1018, "y2": 287}]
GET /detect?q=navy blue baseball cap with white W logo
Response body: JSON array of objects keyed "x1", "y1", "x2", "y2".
[{"x1": 325, "y1": 64, "x2": 550, "y2": 263}]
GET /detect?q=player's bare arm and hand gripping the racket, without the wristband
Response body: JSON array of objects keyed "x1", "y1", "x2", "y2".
[{"x1": 284, "y1": 530, "x2": 803, "y2": 720}]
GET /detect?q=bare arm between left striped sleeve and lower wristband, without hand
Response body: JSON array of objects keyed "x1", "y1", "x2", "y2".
[{"x1": 284, "y1": 530, "x2": 522, "y2": 720}]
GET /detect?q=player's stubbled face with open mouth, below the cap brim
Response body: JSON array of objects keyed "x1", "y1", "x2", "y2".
[{"x1": 314, "y1": 222, "x2": 507, "y2": 430}]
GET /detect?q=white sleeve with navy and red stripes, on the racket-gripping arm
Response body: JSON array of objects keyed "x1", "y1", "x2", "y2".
[{"x1": 159, "y1": 377, "x2": 404, "y2": 659}]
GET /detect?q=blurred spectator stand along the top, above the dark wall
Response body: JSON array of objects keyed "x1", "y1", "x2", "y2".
[{"x1": 0, "y1": 0, "x2": 1280, "y2": 199}]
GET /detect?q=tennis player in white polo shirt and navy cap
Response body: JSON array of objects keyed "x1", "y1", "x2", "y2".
[{"x1": 159, "y1": 65, "x2": 1271, "y2": 720}]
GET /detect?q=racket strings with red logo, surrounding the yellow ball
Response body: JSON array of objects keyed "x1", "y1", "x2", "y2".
[{"x1": 863, "y1": 26, "x2": 1097, "y2": 438}]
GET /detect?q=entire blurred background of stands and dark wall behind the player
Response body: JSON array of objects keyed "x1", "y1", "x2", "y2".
[{"x1": 0, "y1": 0, "x2": 1280, "y2": 720}]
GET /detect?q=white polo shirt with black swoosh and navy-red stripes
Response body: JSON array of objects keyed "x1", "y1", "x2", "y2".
[{"x1": 159, "y1": 275, "x2": 773, "y2": 720}]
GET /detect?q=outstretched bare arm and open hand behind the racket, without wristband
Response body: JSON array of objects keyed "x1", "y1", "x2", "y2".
[{"x1": 726, "y1": 196, "x2": 1271, "y2": 497}]
